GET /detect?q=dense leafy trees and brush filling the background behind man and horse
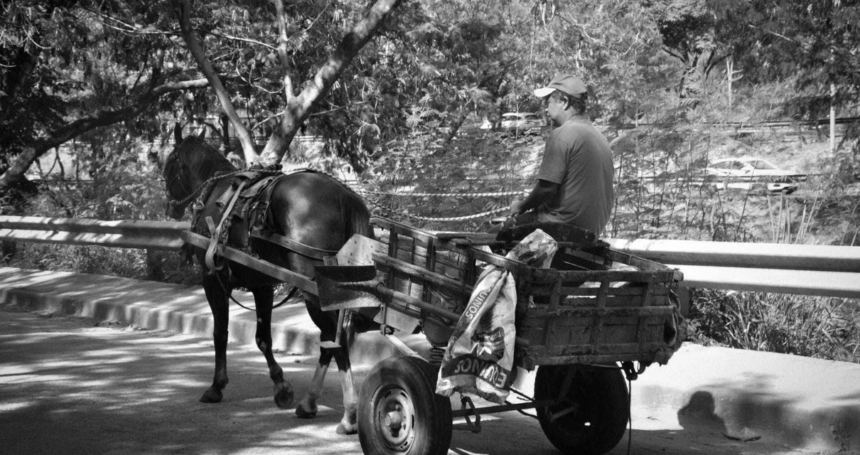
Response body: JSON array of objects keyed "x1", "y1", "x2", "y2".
[{"x1": 0, "y1": 0, "x2": 860, "y2": 366}]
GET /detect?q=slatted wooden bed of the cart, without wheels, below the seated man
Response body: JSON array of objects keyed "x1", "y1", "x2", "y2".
[{"x1": 326, "y1": 218, "x2": 682, "y2": 369}]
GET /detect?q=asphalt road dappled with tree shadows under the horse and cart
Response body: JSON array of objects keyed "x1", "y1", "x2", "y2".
[{"x1": 0, "y1": 306, "x2": 832, "y2": 455}]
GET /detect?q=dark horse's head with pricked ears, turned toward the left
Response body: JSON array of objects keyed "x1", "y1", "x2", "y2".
[{"x1": 163, "y1": 136, "x2": 236, "y2": 220}]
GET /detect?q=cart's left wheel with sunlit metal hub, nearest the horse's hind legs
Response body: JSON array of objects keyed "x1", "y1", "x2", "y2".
[{"x1": 358, "y1": 357, "x2": 452, "y2": 455}]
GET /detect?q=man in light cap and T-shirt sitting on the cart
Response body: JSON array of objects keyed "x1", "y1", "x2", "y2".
[{"x1": 510, "y1": 74, "x2": 615, "y2": 236}]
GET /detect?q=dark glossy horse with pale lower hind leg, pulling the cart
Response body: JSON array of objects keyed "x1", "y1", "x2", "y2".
[{"x1": 164, "y1": 133, "x2": 372, "y2": 434}]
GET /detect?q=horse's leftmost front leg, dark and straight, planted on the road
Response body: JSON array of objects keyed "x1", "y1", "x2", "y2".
[{"x1": 200, "y1": 275, "x2": 230, "y2": 403}]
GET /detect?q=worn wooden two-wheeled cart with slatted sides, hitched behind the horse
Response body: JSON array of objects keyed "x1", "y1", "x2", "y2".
[{"x1": 316, "y1": 219, "x2": 683, "y2": 455}]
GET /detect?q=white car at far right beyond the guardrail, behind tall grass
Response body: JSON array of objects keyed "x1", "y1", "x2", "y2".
[{"x1": 705, "y1": 157, "x2": 806, "y2": 194}]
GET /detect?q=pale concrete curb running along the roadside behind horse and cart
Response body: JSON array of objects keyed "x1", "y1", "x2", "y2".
[{"x1": 0, "y1": 267, "x2": 860, "y2": 453}]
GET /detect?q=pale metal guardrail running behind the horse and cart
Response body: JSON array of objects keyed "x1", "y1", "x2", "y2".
[{"x1": 0, "y1": 216, "x2": 860, "y2": 298}]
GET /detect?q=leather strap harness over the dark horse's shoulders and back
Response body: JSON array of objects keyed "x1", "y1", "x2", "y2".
[{"x1": 191, "y1": 169, "x2": 337, "y2": 280}]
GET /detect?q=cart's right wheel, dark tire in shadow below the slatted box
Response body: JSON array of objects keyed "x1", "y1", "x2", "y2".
[{"x1": 535, "y1": 365, "x2": 630, "y2": 455}]
